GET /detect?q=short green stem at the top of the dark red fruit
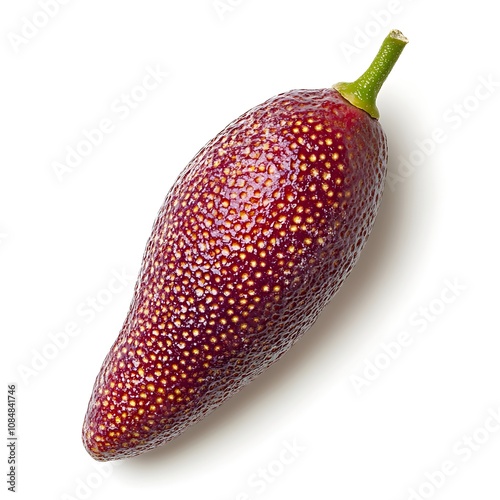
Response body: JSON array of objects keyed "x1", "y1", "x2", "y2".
[{"x1": 333, "y1": 30, "x2": 408, "y2": 119}]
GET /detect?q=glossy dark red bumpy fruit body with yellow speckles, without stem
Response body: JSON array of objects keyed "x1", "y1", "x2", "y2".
[{"x1": 83, "y1": 89, "x2": 387, "y2": 460}]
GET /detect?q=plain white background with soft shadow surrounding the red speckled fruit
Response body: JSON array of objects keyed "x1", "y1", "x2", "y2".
[{"x1": 0, "y1": 0, "x2": 500, "y2": 500}]
